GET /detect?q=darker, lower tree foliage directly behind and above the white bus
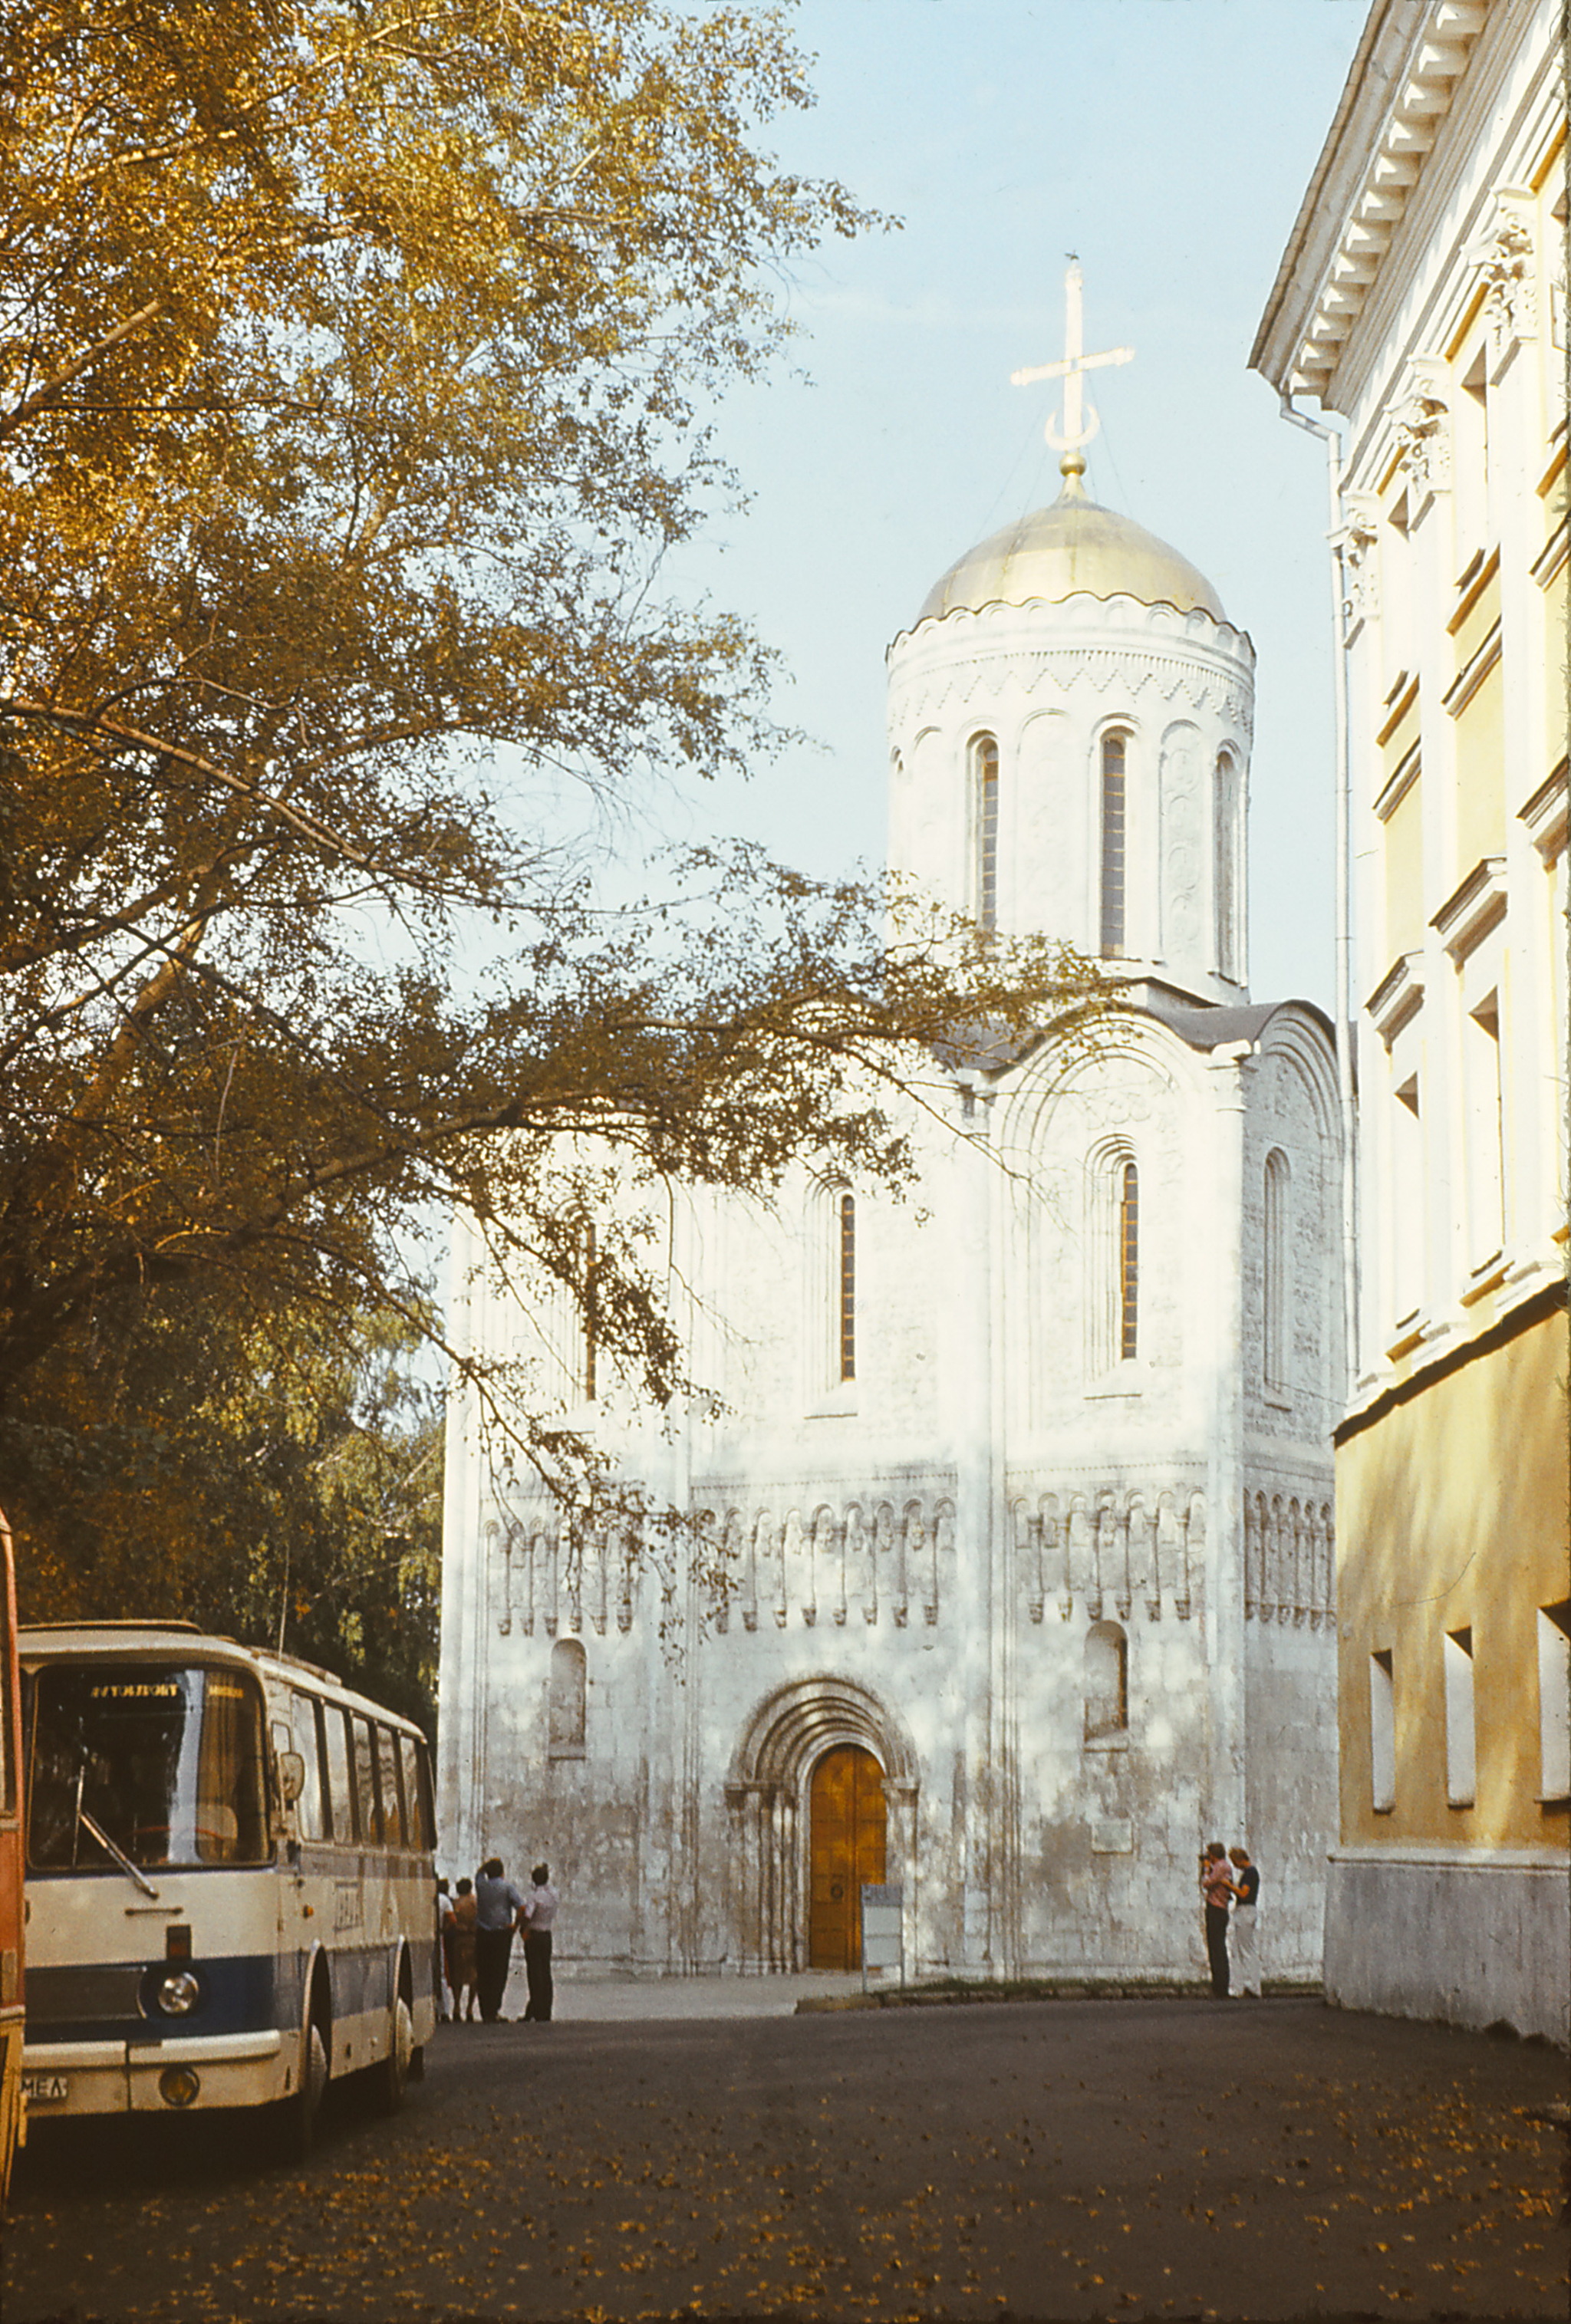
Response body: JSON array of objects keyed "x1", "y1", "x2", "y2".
[{"x1": 0, "y1": 1288, "x2": 442, "y2": 1731}]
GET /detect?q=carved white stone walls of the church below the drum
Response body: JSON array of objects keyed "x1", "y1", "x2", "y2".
[{"x1": 444, "y1": 980, "x2": 1334, "y2": 1978}]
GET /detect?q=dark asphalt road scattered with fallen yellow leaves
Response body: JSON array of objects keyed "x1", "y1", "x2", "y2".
[{"x1": 2, "y1": 1999, "x2": 1569, "y2": 2324}]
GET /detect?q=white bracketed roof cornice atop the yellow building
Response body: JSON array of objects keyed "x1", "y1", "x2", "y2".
[{"x1": 1250, "y1": 0, "x2": 1501, "y2": 404}]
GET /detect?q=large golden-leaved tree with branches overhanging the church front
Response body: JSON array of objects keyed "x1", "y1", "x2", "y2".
[{"x1": 0, "y1": 0, "x2": 1095, "y2": 1524}]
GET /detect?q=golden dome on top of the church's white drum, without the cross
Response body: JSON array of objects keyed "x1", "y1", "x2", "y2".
[{"x1": 916, "y1": 460, "x2": 1227, "y2": 621}]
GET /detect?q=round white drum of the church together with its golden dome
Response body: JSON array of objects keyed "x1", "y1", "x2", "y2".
[{"x1": 888, "y1": 476, "x2": 1255, "y2": 1004}]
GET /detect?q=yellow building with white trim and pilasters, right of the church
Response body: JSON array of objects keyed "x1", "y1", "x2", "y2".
[{"x1": 1250, "y1": 0, "x2": 1571, "y2": 2040}]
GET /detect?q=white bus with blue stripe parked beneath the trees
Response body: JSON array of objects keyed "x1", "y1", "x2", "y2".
[{"x1": 18, "y1": 1622, "x2": 437, "y2": 2157}]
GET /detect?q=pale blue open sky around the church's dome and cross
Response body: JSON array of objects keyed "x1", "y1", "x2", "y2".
[{"x1": 662, "y1": 0, "x2": 1366, "y2": 1004}]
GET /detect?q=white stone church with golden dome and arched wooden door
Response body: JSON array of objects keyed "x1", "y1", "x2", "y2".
[{"x1": 440, "y1": 328, "x2": 1343, "y2": 1978}]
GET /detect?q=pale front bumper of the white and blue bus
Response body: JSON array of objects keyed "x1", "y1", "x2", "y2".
[{"x1": 21, "y1": 2029, "x2": 291, "y2": 2122}]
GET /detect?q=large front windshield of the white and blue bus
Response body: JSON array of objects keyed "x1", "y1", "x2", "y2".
[{"x1": 28, "y1": 1661, "x2": 269, "y2": 1871}]
